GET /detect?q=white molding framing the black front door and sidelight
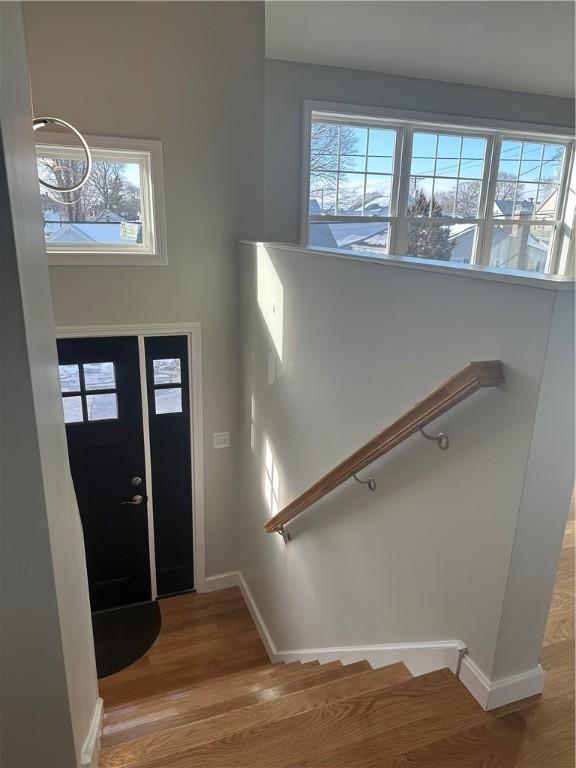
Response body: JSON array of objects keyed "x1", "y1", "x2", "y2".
[{"x1": 55, "y1": 323, "x2": 206, "y2": 600}]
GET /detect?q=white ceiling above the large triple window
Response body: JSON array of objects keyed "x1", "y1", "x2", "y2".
[{"x1": 266, "y1": 0, "x2": 575, "y2": 97}]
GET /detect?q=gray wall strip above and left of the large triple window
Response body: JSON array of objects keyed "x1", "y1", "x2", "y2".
[{"x1": 265, "y1": 60, "x2": 574, "y2": 243}]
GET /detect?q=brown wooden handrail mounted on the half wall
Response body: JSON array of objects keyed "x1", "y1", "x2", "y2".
[{"x1": 264, "y1": 360, "x2": 504, "y2": 533}]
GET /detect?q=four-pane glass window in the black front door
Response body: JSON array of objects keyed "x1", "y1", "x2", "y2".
[{"x1": 58, "y1": 362, "x2": 118, "y2": 424}]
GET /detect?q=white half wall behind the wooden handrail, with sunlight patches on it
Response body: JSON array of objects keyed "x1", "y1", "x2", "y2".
[{"x1": 240, "y1": 240, "x2": 573, "y2": 678}]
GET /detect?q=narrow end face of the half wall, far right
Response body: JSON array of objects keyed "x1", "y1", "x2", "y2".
[{"x1": 493, "y1": 294, "x2": 575, "y2": 678}]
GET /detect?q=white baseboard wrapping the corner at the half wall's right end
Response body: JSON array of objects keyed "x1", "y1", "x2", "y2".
[{"x1": 460, "y1": 656, "x2": 544, "y2": 709}]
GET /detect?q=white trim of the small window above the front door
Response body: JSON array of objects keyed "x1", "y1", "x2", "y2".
[{"x1": 36, "y1": 131, "x2": 168, "y2": 267}]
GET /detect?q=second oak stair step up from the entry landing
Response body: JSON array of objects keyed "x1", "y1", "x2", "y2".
[{"x1": 102, "y1": 662, "x2": 356, "y2": 748}]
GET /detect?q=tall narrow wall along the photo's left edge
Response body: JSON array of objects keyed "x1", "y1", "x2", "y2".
[{"x1": 0, "y1": 3, "x2": 98, "y2": 768}]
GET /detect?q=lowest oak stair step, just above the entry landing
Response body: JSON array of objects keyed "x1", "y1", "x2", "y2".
[{"x1": 103, "y1": 661, "x2": 325, "y2": 734}]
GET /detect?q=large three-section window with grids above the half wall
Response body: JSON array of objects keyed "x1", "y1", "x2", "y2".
[{"x1": 306, "y1": 112, "x2": 572, "y2": 272}]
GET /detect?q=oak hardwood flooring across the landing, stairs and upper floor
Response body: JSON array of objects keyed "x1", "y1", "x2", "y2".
[{"x1": 100, "y1": 510, "x2": 575, "y2": 768}]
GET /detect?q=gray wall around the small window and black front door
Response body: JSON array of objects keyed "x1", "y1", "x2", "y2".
[{"x1": 25, "y1": 2, "x2": 264, "y2": 574}]
